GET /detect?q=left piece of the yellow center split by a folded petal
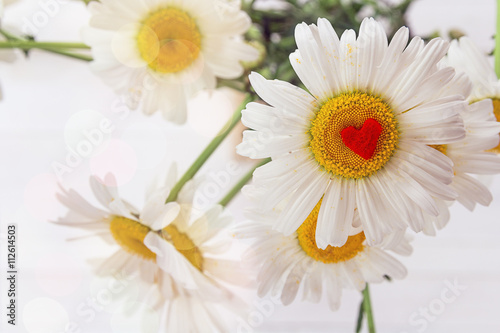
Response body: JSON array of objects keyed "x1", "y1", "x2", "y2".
[{"x1": 109, "y1": 216, "x2": 156, "y2": 260}]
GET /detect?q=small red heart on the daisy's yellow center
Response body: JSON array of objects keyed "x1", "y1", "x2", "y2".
[{"x1": 340, "y1": 118, "x2": 382, "y2": 160}]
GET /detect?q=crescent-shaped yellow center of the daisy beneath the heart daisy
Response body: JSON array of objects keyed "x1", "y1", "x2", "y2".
[{"x1": 297, "y1": 200, "x2": 365, "y2": 264}]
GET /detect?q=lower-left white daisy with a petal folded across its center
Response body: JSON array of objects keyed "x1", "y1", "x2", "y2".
[{"x1": 56, "y1": 172, "x2": 248, "y2": 332}]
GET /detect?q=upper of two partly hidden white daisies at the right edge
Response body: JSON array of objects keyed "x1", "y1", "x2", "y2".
[{"x1": 447, "y1": 37, "x2": 500, "y2": 153}]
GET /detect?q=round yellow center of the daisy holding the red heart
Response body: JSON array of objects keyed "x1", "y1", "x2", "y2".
[{"x1": 309, "y1": 91, "x2": 399, "y2": 179}]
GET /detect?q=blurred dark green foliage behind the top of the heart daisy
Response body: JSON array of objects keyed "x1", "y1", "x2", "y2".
[{"x1": 244, "y1": 0, "x2": 413, "y2": 85}]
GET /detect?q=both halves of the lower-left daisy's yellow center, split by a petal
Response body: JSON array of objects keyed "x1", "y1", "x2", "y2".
[{"x1": 110, "y1": 216, "x2": 203, "y2": 271}]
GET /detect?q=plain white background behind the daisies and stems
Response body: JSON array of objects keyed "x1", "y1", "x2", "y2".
[{"x1": 0, "y1": 0, "x2": 500, "y2": 333}]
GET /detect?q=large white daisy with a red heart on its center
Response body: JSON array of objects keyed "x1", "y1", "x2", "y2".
[{"x1": 238, "y1": 19, "x2": 467, "y2": 249}]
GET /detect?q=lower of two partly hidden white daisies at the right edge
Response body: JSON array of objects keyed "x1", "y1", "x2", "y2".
[{"x1": 423, "y1": 73, "x2": 500, "y2": 235}]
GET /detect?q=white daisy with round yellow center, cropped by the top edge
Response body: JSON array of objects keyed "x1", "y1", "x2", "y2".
[{"x1": 84, "y1": 0, "x2": 258, "y2": 123}]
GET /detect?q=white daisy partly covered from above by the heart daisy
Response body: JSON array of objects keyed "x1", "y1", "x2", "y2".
[{"x1": 235, "y1": 197, "x2": 412, "y2": 311}]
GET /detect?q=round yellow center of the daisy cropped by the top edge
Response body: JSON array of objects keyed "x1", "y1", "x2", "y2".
[{"x1": 137, "y1": 7, "x2": 201, "y2": 73}]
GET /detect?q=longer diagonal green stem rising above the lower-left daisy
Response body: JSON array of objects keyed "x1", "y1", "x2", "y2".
[{"x1": 165, "y1": 94, "x2": 253, "y2": 203}]
